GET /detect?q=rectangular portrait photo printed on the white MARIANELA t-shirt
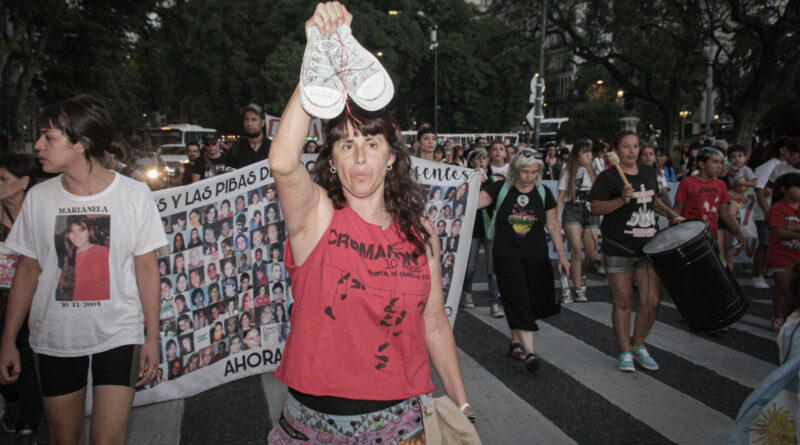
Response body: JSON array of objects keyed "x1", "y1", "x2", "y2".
[{"x1": 54, "y1": 212, "x2": 111, "y2": 301}]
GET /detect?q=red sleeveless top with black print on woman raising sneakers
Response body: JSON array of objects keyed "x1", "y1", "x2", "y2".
[{"x1": 275, "y1": 206, "x2": 434, "y2": 400}]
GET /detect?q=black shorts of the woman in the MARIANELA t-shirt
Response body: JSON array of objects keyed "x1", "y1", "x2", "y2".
[{"x1": 36, "y1": 345, "x2": 142, "y2": 397}]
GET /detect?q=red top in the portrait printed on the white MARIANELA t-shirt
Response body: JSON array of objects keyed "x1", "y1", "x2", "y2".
[{"x1": 73, "y1": 244, "x2": 111, "y2": 301}]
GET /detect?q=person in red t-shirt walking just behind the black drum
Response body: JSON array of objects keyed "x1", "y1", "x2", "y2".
[{"x1": 673, "y1": 148, "x2": 744, "y2": 248}]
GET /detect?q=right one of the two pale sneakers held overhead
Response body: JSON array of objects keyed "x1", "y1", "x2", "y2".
[{"x1": 328, "y1": 25, "x2": 394, "y2": 111}]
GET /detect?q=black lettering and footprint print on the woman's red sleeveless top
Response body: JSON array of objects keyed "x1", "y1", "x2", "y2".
[{"x1": 322, "y1": 229, "x2": 429, "y2": 370}]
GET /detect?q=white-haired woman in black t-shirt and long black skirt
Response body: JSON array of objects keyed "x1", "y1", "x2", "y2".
[{"x1": 478, "y1": 149, "x2": 569, "y2": 372}]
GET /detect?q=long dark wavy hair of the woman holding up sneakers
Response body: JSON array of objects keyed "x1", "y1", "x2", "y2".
[{"x1": 312, "y1": 103, "x2": 430, "y2": 256}]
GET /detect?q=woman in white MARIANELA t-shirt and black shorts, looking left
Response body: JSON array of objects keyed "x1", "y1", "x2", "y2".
[{"x1": 0, "y1": 96, "x2": 167, "y2": 443}]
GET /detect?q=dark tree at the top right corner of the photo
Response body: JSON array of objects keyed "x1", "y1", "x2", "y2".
[{"x1": 704, "y1": 0, "x2": 800, "y2": 147}]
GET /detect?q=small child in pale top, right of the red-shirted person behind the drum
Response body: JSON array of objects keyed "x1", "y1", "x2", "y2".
[{"x1": 720, "y1": 145, "x2": 756, "y2": 271}]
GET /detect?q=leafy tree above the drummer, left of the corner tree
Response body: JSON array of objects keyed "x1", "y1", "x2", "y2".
[{"x1": 550, "y1": 0, "x2": 706, "y2": 153}]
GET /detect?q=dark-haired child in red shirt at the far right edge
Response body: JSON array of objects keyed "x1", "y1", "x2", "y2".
[{"x1": 767, "y1": 173, "x2": 800, "y2": 331}]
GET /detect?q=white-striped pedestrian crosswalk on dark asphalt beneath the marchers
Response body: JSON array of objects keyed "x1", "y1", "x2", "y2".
[{"x1": 29, "y1": 276, "x2": 778, "y2": 444}]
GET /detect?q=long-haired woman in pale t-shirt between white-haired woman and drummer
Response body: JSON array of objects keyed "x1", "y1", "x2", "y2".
[{"x1": 556, "y1": 139, "x2": 600, "y2": 303}]
